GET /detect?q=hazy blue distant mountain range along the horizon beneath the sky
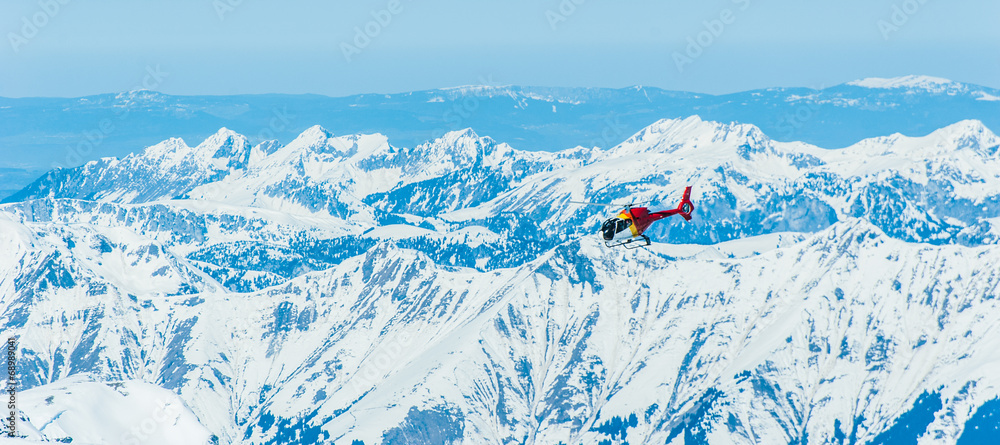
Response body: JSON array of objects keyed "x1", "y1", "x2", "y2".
[{"x1": 0, "y1": 76, "x2": 1000, "y2": 184}]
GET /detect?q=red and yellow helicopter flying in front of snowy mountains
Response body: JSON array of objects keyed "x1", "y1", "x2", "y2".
[{"x1": 570, "y1": 187, "x2": 694, "y2": 249}]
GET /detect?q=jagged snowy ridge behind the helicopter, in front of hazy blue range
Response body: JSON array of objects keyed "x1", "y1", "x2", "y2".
[{"x1": 5, "y1": 116, "x2": 1000, "y2": 250}]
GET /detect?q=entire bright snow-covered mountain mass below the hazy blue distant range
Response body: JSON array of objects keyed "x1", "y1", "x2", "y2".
[{"x1": 0, "y1": 116, "x2": 1000, "y2": 445}]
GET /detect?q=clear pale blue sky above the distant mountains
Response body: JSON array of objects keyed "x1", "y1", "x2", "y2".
[{"x1": 0, "y1": 0, "x2": 1000, "y2": 97}]
